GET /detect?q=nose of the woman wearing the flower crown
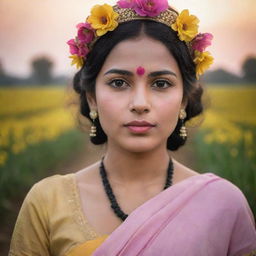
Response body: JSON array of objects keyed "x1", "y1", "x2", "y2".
[{"x1": 129, "y1": 86, "x2": 151, "y2": 114}]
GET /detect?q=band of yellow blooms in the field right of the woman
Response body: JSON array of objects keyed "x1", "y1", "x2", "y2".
[{"x1": 191, "y1": 86, "x2": 256, "y2": 157}]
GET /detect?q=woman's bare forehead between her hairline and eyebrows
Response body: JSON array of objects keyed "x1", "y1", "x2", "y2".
[{"x1": 98, "y1": 36, "x2": 179, "y2": 74}]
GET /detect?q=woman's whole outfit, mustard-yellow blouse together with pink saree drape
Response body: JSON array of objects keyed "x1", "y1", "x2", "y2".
[{"x1": 9, "y1": 173, "x2": 256, "y2": 256}]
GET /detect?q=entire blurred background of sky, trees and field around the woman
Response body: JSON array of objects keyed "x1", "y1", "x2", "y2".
[{"x1": 0, "y1": 0, "x2": 256, "y2": 255}]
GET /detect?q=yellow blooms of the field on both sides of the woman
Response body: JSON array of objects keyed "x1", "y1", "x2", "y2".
[{"x1": 0, "y1": 86, "x2": 256, "y2": 166}]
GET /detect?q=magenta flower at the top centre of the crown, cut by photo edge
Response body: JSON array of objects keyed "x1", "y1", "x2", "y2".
[{"x1": 134, "y1": 0, "x2": 168, "y2": 17}]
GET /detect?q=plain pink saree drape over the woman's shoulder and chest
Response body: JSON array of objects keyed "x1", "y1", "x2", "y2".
[{"x1": 93, "y1": 173, "x2": 256, "y2": 256}]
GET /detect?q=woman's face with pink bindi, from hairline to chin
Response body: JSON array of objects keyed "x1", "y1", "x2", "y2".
[{"x1": 88, "y1": 36, "x2": 184, "y2": 152}]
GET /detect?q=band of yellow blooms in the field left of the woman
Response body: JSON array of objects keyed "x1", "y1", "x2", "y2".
[{"x1": 0, "y1": 87, "x2": 79, "y2": 166}]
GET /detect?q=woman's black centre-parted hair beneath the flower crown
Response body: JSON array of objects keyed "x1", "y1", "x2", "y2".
[{"x1": 73, "y1": 20, "x2": 203, "y2": 151}]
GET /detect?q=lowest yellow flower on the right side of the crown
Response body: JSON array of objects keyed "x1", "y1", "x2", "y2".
[{"x1": 194, "y1": 50, "x2": 214, "y2": 79}]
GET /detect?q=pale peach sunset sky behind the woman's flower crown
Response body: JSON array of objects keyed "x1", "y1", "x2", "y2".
[{"x1": 0, "y1": 0, "x2": 256, "y2": 76}]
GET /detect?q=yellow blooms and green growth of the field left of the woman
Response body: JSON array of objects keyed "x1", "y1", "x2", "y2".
[{"x1": 0, "y1": 86, "x2": 87, "y2": 244}]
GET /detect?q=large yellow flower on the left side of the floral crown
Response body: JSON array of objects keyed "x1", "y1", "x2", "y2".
[{"x1": 87, "y1": 4, "x2": 119, "y2": 36}]
